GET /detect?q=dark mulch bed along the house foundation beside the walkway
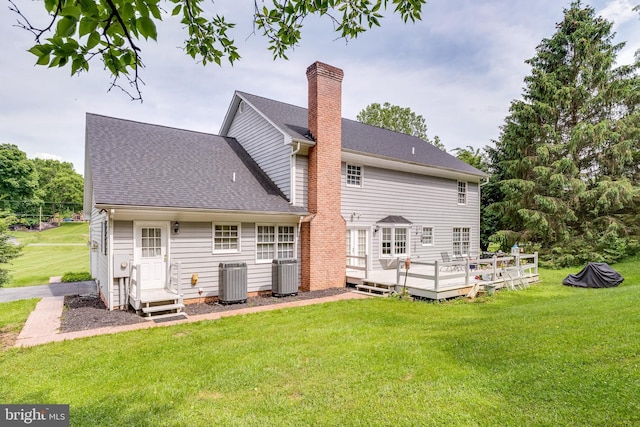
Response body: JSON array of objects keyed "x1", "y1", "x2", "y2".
[{"x1": 60, "y1": 288, "x2": 351, "y2": 333}]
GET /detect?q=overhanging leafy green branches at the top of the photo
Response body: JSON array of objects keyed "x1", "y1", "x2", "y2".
[{"x1": 8, "y1": 0, "x2": 426, "y2": 101}]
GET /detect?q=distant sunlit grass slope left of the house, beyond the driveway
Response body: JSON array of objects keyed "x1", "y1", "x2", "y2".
[{"x1": 5, "y1": 223, "x2": 89, "y2": 287}]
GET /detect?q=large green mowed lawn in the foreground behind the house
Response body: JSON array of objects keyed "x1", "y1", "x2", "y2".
[{"x1": 0, "y1": 259, "x2": 640, "y2": 426}]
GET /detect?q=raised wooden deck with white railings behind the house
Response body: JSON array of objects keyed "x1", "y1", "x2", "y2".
[{"x1": 347, "y1": 253, "x2": 538, "y2": 300}]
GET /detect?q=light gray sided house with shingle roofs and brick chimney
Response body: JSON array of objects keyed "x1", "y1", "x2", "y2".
[{"x1": 85, "y1": 62, "x2": 486, "y2": 312}]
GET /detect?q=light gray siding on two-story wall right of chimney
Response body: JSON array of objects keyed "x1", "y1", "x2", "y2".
[{"x1": 341, "y1": 162, "x2": 480, "y2": 270}]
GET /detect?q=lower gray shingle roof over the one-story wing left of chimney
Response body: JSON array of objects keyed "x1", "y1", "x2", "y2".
[{"x1": 86, "y1": 114, "x2": 305, "y2": 214}]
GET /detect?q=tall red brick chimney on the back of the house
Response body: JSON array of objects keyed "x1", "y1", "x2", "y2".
[{"x1": 301, "y1": 62, "x2": 347, "y2": 291}]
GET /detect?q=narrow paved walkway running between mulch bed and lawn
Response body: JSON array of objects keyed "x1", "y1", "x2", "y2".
[{"x1": 15, "y1": 292, "x2": 368, "y2": 347}]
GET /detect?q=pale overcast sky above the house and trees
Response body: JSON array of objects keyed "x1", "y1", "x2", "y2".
[{"x1": 0, "y1": 0, "x2": 640, "y2": 174}]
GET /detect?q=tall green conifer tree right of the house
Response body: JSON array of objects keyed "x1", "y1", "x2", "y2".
[{"x1": 490, "y1": 1, "x2": 640, "y2": 265}]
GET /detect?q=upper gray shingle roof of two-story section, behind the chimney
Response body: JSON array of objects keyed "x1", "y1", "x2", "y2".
[{"x1": 237, "y1": 92, "x2": 487, "y2": 177}]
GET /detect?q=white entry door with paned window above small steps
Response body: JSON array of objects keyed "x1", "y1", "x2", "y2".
[{"x1": 135, "y1": 222, "x2": 167, "y2": 290}]
